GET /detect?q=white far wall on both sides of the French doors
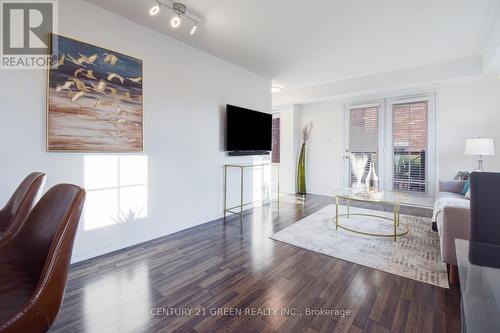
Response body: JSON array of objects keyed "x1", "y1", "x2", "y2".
[{"x1": 282, "y1": 80, "x2": 500, "y2": 195}]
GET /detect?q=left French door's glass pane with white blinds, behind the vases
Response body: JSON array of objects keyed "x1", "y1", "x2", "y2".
[{"x1": 349, "y1": 106, "x2": 379, "y2": 186}]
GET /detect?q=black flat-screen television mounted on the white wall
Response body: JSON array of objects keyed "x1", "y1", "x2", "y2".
[{"x1": 226, "y1": 105, "x2": 273, "y2": 151}]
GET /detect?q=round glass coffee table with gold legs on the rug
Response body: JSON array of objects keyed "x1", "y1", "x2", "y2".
[{"x1": 334, "y1": 188, "x2": 411, "y2": 241}]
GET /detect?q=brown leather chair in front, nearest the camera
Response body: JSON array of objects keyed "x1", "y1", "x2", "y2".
[{"x1": 0, "y1": 184, "x2": 85, "y2": 333}]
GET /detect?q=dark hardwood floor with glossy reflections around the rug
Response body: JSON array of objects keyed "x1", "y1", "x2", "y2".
[{"x1": 51, "y1": 195, "x2": 459, "y2": 333}]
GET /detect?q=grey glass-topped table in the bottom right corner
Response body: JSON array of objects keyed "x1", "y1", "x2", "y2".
[{"x1": 455, "y1": 239, "x2": 500, "y2": 332}]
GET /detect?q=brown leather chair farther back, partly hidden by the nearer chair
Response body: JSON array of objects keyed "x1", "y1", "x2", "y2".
[{"x1": 0, "y1": 172, "x2": 46, "y2": 238}]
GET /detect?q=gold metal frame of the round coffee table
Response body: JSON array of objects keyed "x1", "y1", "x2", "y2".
[{"x1": 335, "y1": 189, "x2": 410, "y2": 241}]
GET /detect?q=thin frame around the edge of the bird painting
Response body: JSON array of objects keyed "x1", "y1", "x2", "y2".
[{"x1": 45, "y1": 33, "x2": 145, "y2": 153}]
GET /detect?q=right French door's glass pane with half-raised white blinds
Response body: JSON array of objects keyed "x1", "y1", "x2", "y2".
[{"x1": 392, "y1": 101, "x2": 428, "y2": 192}]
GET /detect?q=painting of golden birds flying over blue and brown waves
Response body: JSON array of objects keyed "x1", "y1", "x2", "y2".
[{"x1": 47, "y1": 34, "x2": 144, "y2": 152}]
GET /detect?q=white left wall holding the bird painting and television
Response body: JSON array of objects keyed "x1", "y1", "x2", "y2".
[{"x1": 0, "y1": 0, "x2": 271, "y2": 261}]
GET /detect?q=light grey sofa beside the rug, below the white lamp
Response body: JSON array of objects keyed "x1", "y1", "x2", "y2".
[{"x1": 436, "y1": 180, "x2": 470, "y2": 269}]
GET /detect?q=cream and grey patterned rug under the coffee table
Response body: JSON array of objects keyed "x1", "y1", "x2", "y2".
[{"x1": 270, "y1": 205, "x2": 449, "y2": 288}]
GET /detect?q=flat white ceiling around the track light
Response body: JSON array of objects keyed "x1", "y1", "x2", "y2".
[{"x1": 87, "y1": 0, "x2": 499, "y2": 88}]
